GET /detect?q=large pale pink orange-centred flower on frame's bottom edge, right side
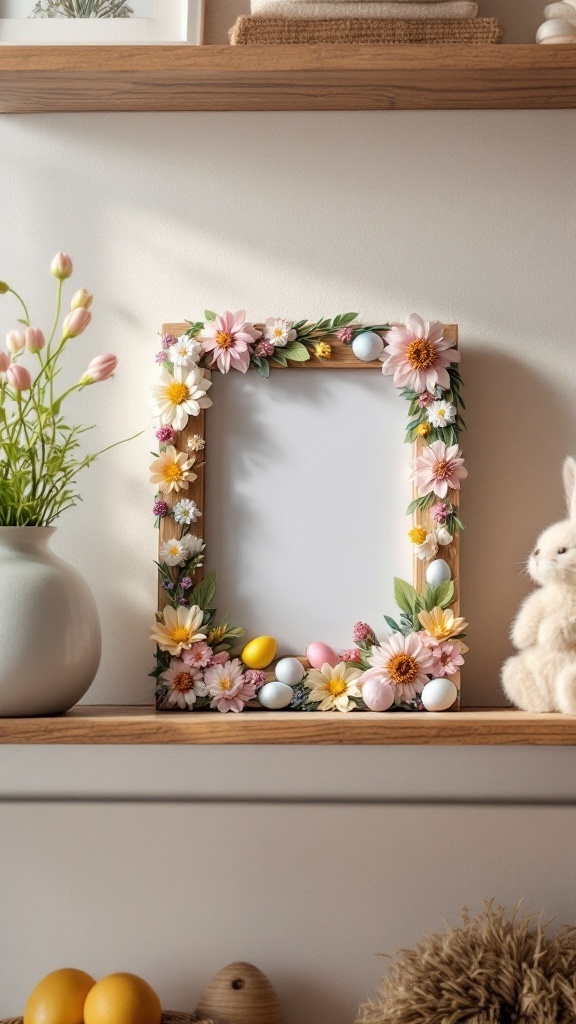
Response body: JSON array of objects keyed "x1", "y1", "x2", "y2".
[{"x1": 360, "y1": 633, "x2": 431, "y2": 705}]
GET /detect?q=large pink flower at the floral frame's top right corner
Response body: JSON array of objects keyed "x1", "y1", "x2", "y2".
[{"x1": 380, "y1": 313, "x2": 460, "y2": 392}]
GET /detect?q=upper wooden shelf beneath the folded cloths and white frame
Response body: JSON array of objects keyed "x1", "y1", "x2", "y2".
[{"x1": 0, "y1": 45, "x2": 576, "y2": 114}]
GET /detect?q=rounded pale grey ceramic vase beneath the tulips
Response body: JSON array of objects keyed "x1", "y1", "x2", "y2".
[{"x1": 0, "y1": 526, "x2": 101, "y2": 718}]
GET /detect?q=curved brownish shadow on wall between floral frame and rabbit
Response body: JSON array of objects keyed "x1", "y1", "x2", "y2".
[{"x1": 461, "y1": 348, "x2": 574, "y2": 706}]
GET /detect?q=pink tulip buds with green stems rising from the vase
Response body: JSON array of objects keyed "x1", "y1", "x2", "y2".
[{"x1": 0, "y1": 253, "x2": 133, "y2": 526}]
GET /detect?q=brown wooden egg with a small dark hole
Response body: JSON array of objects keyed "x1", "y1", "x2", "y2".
[{"x1": 196, "y1": 964, "x2": 282, "y2": 1024}]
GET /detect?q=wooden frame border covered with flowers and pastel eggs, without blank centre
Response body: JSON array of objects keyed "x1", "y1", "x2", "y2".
[{"x1": 151, "y1": 310, "x2": 467, "y2": 713}]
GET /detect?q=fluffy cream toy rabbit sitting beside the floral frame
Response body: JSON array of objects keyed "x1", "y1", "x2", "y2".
[{"x1": 502, "y1": 459, "x2": 576, "y2": 715}]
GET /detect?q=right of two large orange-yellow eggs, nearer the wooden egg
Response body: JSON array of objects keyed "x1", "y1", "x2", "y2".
[{"x1": 84, "y1": 974, "x2": 162, "y2": 1024}]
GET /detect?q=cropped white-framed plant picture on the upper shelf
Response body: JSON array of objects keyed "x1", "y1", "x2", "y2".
[{"x1": 0, "y1": 0, "x2": 204, "y2": 46}]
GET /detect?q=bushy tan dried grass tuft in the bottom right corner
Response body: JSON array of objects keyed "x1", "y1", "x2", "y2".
[{"x1": 356, "y1": 903, "x2": 576, "y2": 1024}]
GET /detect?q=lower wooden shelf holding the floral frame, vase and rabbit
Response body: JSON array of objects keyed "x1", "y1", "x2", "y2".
[{"x1": 0, "y1": 707, "x2": 576, "y2": 746}]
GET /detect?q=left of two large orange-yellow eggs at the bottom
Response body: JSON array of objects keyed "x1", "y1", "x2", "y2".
[{"x1": 24, "y1": 968, "x2": 96, "y2": 1024}]
